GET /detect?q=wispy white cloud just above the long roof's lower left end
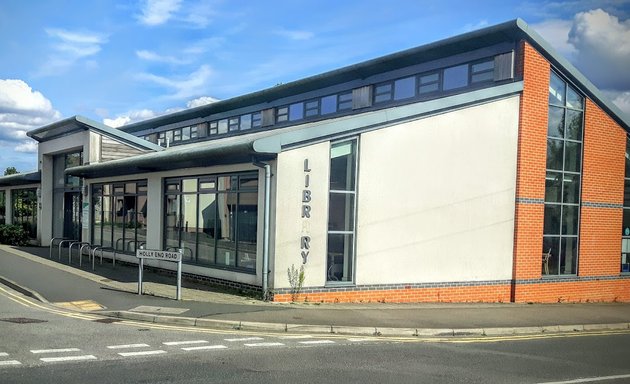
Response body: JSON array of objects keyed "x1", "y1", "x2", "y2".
[{"x1": 137, "y1": 64, "x2": 212, "y2": 99}]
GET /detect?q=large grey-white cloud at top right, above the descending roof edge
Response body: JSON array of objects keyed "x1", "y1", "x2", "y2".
[{"x1": 569, "y1": 9, "x2": 630, "y2": 90}]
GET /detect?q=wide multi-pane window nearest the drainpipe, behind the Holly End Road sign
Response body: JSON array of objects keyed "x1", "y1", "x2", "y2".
[{"x1": 164, "y1": 173, "x2": 258, "y2": 271}]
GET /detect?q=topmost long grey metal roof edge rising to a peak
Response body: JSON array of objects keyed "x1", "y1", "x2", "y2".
[{"x1": 116, "y1": 19, "x2": 630, "y2": 132}]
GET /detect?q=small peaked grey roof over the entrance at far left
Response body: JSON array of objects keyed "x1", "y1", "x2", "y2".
[{"x1": 26, "y1": 116, "x2": 163, "y2": 151}]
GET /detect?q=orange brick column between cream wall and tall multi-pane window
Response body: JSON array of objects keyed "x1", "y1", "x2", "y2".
[{"x1": 513, "y1": 42, "x2": 550, "y2": 288}]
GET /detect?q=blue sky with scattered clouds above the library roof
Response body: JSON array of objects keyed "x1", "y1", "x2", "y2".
[{"x1": 0, "y1": 0, "x2": 630, "y2": 172}]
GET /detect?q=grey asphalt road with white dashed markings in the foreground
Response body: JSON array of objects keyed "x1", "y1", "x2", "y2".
[{"x1": 0, "y1": 280, "x2": 630, "y2": 384}]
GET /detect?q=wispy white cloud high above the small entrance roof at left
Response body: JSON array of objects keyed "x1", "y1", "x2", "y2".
[{"x1": 37, "y1": 28, "x2": 108, "y2": 76}]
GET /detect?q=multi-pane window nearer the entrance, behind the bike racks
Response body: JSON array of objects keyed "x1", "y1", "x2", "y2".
[{"x1": 92, "y1": 180, "x2": 147, "y2": 253}]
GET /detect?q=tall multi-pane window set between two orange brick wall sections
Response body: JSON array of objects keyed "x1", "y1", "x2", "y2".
[{"x1": 542, "y1": 72, "x2": 584, "y2": 275}]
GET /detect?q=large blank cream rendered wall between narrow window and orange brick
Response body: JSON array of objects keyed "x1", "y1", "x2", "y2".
[{"x1": 356, "y1": 96, "x2": 519, "y2": 285}]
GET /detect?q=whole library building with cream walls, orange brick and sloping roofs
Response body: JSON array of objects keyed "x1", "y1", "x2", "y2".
[{"x1": 0, "y1": 19, "x2": 630, "y2": 303}]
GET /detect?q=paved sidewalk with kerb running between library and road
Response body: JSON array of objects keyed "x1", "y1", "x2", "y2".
[{"x1": 0, "y1": 245, "x2": 630, "y2": 336}]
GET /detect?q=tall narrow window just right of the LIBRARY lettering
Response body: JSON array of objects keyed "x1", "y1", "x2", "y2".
[{"x1": 326, "y1": 140, "x2": 357, "y2": 283}]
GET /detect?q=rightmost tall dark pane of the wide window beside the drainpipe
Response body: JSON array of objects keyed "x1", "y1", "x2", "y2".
[{"x1": 237, "y1": 193, "x2": 258, "y2": 269}]
